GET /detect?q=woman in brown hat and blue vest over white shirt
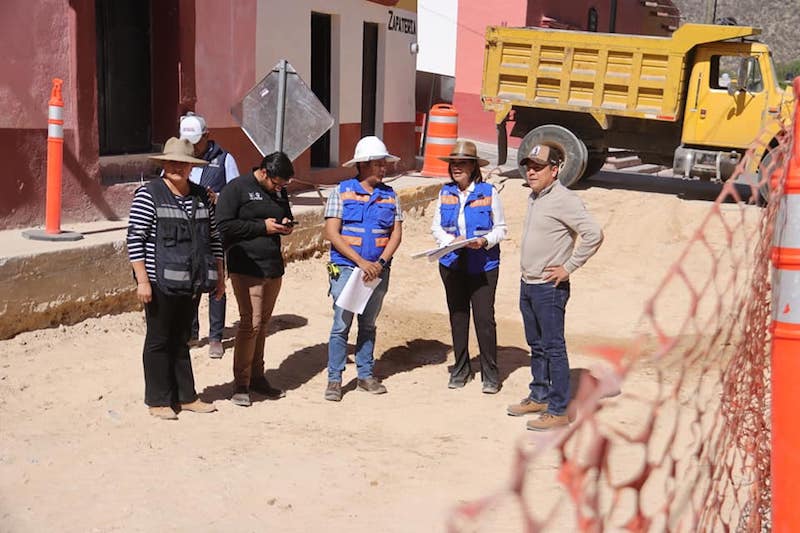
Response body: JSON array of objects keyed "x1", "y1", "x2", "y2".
[{"x1": 431, "y1": 140, "x2": 506, "y2": 394}]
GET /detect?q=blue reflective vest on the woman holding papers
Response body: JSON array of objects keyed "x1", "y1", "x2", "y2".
[{"x1": 439, "y1": 183, "x2": 500, "y2": 274}]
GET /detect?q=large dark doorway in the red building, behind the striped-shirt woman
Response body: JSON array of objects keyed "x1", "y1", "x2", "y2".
[{"x1": 95, "y1": 0, "x2": 152, "y2": 155}]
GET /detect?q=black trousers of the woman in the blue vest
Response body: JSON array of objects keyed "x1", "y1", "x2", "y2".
[{"x1": 439, "y1": 264, "x2": 500, "y2": 385}]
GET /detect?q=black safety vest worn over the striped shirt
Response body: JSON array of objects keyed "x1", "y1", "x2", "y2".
[{"x1": 145, "y1": 179, "x2": 218, "y2": 295}]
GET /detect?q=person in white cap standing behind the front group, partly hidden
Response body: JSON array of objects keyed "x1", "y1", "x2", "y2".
[{"x1": 180, "y1": 111, "x2": 239, "y2": 359}]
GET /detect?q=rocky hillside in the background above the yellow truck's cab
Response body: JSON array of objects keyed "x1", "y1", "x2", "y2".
[{"x1": 672, "y1": 0, "x2": 800, "y2": 63}]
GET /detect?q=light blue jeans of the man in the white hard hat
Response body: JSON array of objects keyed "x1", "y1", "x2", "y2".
[{"x1": 328, "y1": 265, "x2": 389, "y2": 381}]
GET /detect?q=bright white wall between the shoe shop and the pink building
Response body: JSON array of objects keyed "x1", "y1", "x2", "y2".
[{"x1": 417, "y1": 0, "x2": 456, "y2": 77}]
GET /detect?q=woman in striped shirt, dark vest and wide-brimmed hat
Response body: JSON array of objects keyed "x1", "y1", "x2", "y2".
[{"x1": 128, "y1": 137, "x2": 225, "y2": 420}]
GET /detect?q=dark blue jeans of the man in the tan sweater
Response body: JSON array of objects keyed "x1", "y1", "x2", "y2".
[{"x1": 519, "y1": 281, "x2": 569, "y2": 416}]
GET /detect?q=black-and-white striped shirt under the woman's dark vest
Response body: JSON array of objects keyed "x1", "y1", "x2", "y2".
[{"x1": 128, "y1": 187, "x2": 223, "y2": 283}]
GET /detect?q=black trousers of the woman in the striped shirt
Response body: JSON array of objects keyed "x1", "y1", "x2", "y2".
[{"x1": 142, "y1": 283, "x2": 197, "y2": 407}]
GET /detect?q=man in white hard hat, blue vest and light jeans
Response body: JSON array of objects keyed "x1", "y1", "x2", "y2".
[{"x1": 325, "y1": 136, "x2": 403, "y2": 402}]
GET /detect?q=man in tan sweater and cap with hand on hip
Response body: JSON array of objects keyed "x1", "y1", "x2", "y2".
[{"x1": 507, "y1": 144, "x2": 603, "y2": 431}]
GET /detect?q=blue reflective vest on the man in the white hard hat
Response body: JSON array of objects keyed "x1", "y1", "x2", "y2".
[{"x1": 331, "y1": 178, "x2": 397, "y2": 266}]
